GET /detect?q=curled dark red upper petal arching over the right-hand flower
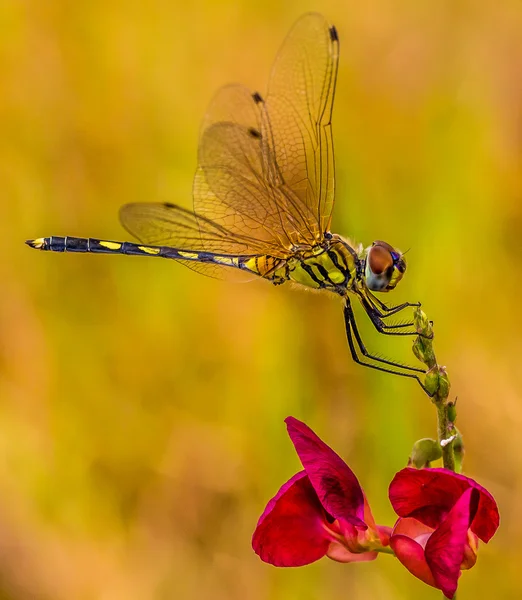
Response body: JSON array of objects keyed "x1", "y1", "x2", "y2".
[{"x1": 389, "y1": 467, "x2": 500, "y2": 542}]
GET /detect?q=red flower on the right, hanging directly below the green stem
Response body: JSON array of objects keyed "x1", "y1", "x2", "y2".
[{"x1": 389, "y1": 467, "x2": 500, "y2": 598}]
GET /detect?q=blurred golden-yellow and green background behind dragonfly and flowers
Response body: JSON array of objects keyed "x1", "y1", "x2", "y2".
[{"x1": 0, "y1": 0, "x2": 522, "y2": 600}]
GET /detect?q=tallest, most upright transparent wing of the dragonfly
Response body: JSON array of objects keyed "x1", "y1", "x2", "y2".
[{"x1": 266, "y1": 13, "x2": 339, "y2": 237}]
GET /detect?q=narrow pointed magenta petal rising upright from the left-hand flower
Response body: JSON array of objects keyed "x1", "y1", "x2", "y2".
[{"x1": 285, "y1": 417, "x2": 366, "y2": 529}]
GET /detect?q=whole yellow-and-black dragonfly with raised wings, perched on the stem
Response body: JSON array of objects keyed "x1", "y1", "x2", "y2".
[{"x1": 26, "y1": 13, "x2": 425, "y2": 388}]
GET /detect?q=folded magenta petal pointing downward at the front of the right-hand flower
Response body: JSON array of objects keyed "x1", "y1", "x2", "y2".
[{"x1": 425, "y1": 488, "x2": 480, "y2": 598}]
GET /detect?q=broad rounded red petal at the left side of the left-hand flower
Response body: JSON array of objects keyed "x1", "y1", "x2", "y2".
[{"x1": 252, "y1": 471, "x2": 331, "y2": 567}]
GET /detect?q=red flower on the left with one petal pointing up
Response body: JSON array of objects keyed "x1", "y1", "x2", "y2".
[{"x1": 252, "y1": 417, "x2": 391, "y2": 567}]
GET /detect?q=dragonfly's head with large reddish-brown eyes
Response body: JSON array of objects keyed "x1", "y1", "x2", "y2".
[{"x1": 364, "y1": 241, "x2": 406, "y2": 292}]
